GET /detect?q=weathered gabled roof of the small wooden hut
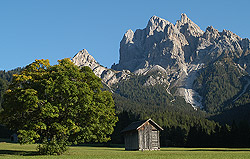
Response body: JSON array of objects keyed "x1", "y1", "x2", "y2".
[{"x1": 121, "y1": 119, "x2": 163, "y2": 133}]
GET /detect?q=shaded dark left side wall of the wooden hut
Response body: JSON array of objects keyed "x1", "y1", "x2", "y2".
[{"x1": 125, "y1": 131, "x2": 139, "y2": 150}]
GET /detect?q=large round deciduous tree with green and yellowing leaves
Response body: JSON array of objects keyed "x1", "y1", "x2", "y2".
[{"x1": 0, "y1": 59, "x2": 118, "y2": 154}]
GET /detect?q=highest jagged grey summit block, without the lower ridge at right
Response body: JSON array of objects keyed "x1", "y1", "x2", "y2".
[{"x1": 112, "y1": 14, "x2": 203, "y2": 72}]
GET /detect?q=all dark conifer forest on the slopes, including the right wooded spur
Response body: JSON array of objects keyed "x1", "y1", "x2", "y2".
[{"x1": 0, "y1": 65, "x2": 250, "y2": 147}]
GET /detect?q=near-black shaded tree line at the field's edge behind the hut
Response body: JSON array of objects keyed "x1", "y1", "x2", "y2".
[{"x1": 110, "y1": 111, "x2": 250, "y2": 148}]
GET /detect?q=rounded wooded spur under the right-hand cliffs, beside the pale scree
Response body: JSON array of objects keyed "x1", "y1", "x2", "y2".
[{"x1": 194, "y1": 57, "x2": 247, "y2": 113}]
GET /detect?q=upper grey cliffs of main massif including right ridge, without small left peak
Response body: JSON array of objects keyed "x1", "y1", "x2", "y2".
[{"x1": 112, "y1": 14, "x2": 249, "y2": 72}]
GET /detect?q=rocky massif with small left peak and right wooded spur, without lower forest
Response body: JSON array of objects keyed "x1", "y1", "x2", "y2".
[{"x1": 72, "y1": 14, "x2": 250, "y2": 114}]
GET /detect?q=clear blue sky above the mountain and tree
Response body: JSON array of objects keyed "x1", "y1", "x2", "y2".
[{"x1": 0, "y1": 0, "x2": 250, "y2": 71}]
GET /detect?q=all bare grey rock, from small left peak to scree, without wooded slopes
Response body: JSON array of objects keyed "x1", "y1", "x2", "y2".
[{"x1": 72, "y1": 14, "x2": 250, "y2": 110}]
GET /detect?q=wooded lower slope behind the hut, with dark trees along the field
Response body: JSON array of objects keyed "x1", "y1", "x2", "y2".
[{"x1": 109, "y1": 76, "x2": 250, "y2": 147}]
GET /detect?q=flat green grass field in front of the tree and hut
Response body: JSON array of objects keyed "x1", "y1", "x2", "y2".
[{"x1": 0, "y1": 142, "x2": 250, "y2": 159}]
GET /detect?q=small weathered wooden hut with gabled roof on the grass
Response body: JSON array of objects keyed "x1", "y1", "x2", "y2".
[{"x1": 121, "y1": 119, "x2": 163, "y2": 150}]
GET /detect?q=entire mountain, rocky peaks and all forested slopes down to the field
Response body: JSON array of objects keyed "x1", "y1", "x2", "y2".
[{"x1": 0, "y1": 14, "x2": 250, "y2": 147}]
